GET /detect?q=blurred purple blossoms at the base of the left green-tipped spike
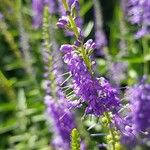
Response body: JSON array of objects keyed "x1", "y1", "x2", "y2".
[{"x1": 45, "y1": 96, "x2": 75, "y2": 150}]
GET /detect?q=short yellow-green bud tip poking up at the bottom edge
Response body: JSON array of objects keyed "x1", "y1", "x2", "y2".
[{"x1": 71, "y1": 128, "x2": 81, "y2": 150}]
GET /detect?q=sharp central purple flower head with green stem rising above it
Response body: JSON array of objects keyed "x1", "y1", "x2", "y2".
[{"x1": 60, "y1": 1, "x2": 119, "y2": 116}]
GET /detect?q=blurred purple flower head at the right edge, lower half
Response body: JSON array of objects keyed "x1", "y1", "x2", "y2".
[{"x1": 128, "y1": 81, "x2": 150, "y2": 136}]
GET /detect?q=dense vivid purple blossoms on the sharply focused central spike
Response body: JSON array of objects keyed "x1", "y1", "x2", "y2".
[{"x1": 60, "y1": 41, "x2": 119, "y2": 116}]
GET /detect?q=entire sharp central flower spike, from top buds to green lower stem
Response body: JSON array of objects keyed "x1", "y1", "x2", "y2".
[{"x1": 57, "y1": 0, "x2": 124, "y2": 150}]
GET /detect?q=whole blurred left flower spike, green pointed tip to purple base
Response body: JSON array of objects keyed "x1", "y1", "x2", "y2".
[{"x1": 43, "y1": 7, "x2": 75, "y2": 150}]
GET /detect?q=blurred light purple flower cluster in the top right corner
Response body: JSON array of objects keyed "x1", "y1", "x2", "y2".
[{"x1": 127, "y1": 0, "x2": 150, "y2": 38}]
